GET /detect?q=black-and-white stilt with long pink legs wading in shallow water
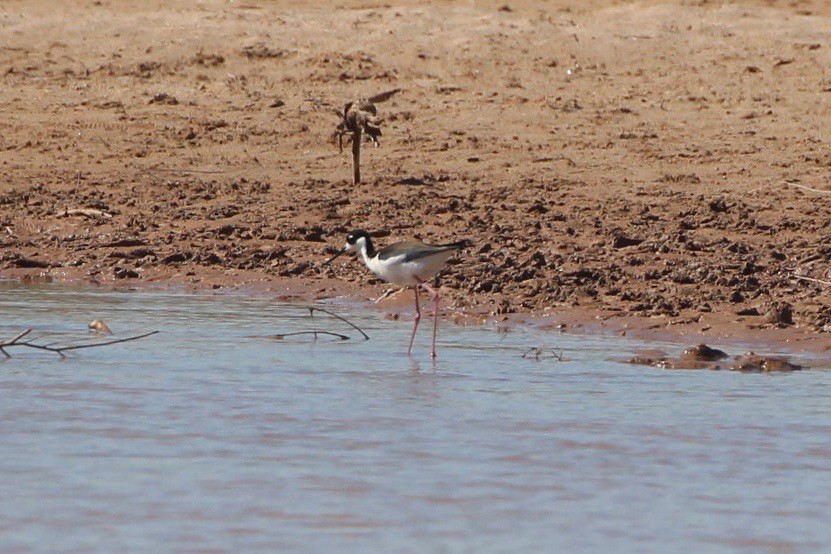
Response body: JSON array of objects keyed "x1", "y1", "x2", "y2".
[{"x1": 324, "y1": 229, "x2": 467, "y2": 358}]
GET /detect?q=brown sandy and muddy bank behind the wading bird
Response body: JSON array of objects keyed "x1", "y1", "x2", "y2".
[{"x1": 0, "y1": 0, "x2": 831, "y2": 351}]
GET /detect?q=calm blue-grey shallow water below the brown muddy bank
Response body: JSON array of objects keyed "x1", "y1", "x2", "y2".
[{"x1": 0, "y1": 283, "x2": 831, "y2": 553}]
